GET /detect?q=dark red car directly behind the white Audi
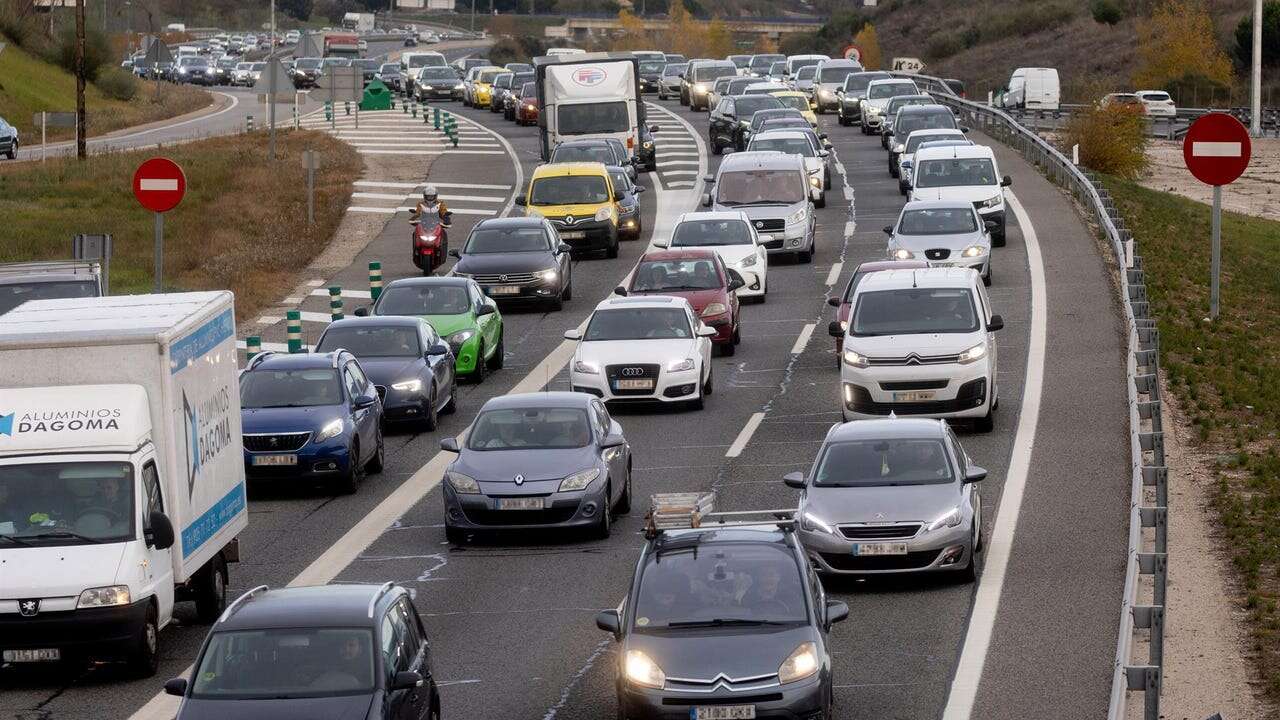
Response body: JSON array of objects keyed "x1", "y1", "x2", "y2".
[{"x1": 613, "y1": 247, "x2": 746, "y2": 355}]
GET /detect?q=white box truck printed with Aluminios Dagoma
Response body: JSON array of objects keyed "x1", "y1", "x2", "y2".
[{"x1": 0, "y1": 292, "x2": 248, "y2": 675}]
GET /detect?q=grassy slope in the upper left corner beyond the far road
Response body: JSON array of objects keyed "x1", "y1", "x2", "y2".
[{"x1": 0, "y1": 38, "x2": 212, "y2": 146}]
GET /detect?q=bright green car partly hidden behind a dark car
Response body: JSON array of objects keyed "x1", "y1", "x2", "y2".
[{"x1": 357, "y1": 277, "x2": 504, "y2": 382}]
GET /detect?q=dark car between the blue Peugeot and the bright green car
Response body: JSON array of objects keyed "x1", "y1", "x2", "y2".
[{"x1": 316, "y1": 315, "x2": 458, "y2": 430}]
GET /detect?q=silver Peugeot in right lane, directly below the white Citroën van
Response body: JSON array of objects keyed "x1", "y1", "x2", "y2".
[{"x1": 783, "y1": 418, "x2": 987, "y2": 582}]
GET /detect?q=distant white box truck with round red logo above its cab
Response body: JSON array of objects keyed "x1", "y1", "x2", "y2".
[{"x1": 534, "y1": 53, "x2": 645, "y2": 160}]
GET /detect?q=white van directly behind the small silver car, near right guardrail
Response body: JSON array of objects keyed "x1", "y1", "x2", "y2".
[{"x1": 910, "y1": 145, "x2": 1014, "y2": 247}]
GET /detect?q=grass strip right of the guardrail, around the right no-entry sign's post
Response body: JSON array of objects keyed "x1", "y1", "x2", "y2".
[{"x1": 1106, "y1": 178, "x2": 1280, "y2": 700}]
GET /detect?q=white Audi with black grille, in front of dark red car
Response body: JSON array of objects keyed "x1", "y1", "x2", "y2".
[{"x1": 564, "y1": 295, "x2": 716, "y2": 407}]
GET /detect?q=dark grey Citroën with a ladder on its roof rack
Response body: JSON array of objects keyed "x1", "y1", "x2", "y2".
[{"x1": 595, "y1": 493, "x2": 849, "y2": 720}]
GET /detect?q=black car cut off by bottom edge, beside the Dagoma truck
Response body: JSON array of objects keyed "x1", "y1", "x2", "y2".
[{"x1": 164, "y1": 583, "x2": 440, "y2": 720}]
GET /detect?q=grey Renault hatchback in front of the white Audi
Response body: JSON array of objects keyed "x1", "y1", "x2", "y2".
[{"x1": 440, "y1": 392, "x2": 631, "y2": 543}]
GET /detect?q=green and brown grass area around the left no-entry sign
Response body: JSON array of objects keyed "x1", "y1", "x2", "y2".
[{"x1": 0, "y1": 131, "x2": 362, "y2": 319}]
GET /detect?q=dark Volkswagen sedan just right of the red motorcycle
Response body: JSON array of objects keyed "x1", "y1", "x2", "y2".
[{"x1": 449, "y1": 218, "x2": 573, "y2": 310}]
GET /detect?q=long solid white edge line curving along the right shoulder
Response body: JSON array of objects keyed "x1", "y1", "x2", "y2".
[{"x1": 942, "y1": 192, "x2": 1047, "y2": 720}]
